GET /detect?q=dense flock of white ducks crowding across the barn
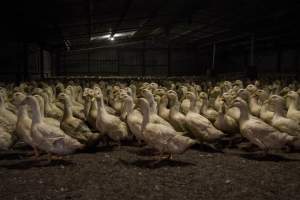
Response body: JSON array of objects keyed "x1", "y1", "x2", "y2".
[{"x1": 0, "y1": 80, "x2": 300, "y2": 161}]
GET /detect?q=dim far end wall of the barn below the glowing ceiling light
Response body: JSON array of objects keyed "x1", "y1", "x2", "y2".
[{"x1": 58, "y1": 47, "x2": 200, "y2": 76}]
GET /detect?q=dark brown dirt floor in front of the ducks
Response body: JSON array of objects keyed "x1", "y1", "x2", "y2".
[{"x1": 0, "y1": 146, "x2": 300, "y2": 200}]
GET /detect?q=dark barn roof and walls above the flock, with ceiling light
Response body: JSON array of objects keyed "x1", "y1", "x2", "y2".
[{"x1": 1, "y1": 0, "x2": 299, "y2": 80}]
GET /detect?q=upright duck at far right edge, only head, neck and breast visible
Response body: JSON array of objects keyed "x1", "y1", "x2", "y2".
[{"x1": 286, "y1": 91, "x2": 300, "y2": 123}]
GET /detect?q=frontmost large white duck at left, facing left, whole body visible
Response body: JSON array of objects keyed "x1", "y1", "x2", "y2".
[{"x1": 20, "y1": 95, "x2": 84, "y2": 156}]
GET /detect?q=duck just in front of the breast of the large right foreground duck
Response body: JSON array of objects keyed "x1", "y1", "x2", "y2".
[{"x1": 214, "y1": 101, "x2": 239, "y2": 134}]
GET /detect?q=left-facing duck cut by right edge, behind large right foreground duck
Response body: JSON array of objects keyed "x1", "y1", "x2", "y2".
[{"x1": 270, "y1": 95, "x2": 300, "y2": 136}]
